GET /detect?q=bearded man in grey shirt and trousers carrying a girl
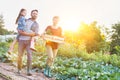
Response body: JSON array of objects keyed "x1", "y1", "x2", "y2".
[{"x1": 18, "y1": 10, "x2": 39, "y2": 76}]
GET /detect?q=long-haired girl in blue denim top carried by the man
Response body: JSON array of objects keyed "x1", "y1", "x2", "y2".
[{"x1": 8, "y1": 9, "x2": 36, "y2": 54}]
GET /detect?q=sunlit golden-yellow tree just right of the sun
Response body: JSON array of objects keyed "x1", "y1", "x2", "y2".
[{"x1": 78, "y1": 21, "x2": 104, "y2": 53}]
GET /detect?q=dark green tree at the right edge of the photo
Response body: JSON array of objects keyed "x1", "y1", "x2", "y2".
[{"x1": 110, "y1": 22, "x2": 120, "y2": 53}]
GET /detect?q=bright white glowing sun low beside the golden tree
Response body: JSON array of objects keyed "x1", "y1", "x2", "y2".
[{"x1": 62, "y1": 19, "x2": 80, "y2": 32}]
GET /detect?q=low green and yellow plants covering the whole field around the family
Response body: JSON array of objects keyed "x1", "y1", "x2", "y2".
[{"x1": 0, "y1": 31, "x2": 120, "y2": 80}]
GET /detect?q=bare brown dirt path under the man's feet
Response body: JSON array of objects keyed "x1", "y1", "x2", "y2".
[{"x1": 0, "y1": 63, "x2": 55, "y2": 80}]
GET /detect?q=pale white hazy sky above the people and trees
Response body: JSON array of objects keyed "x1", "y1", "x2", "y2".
[{"x1": 0, "y1": 0, "x2": 120, "y2": 32}]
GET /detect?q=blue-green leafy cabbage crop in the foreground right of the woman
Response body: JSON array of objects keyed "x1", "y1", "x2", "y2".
[{"x1": 53, "y1": 57, "x2": 120, "y2": 80}]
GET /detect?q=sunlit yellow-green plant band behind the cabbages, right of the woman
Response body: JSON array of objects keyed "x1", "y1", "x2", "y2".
[{"x1": 58, "y1": 43, "x2": 120, "y2": 67}]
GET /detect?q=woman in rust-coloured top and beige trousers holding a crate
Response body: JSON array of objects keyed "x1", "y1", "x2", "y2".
[{"x1": 44, "y1": 16, "x2": 62, "y2": 77}]
